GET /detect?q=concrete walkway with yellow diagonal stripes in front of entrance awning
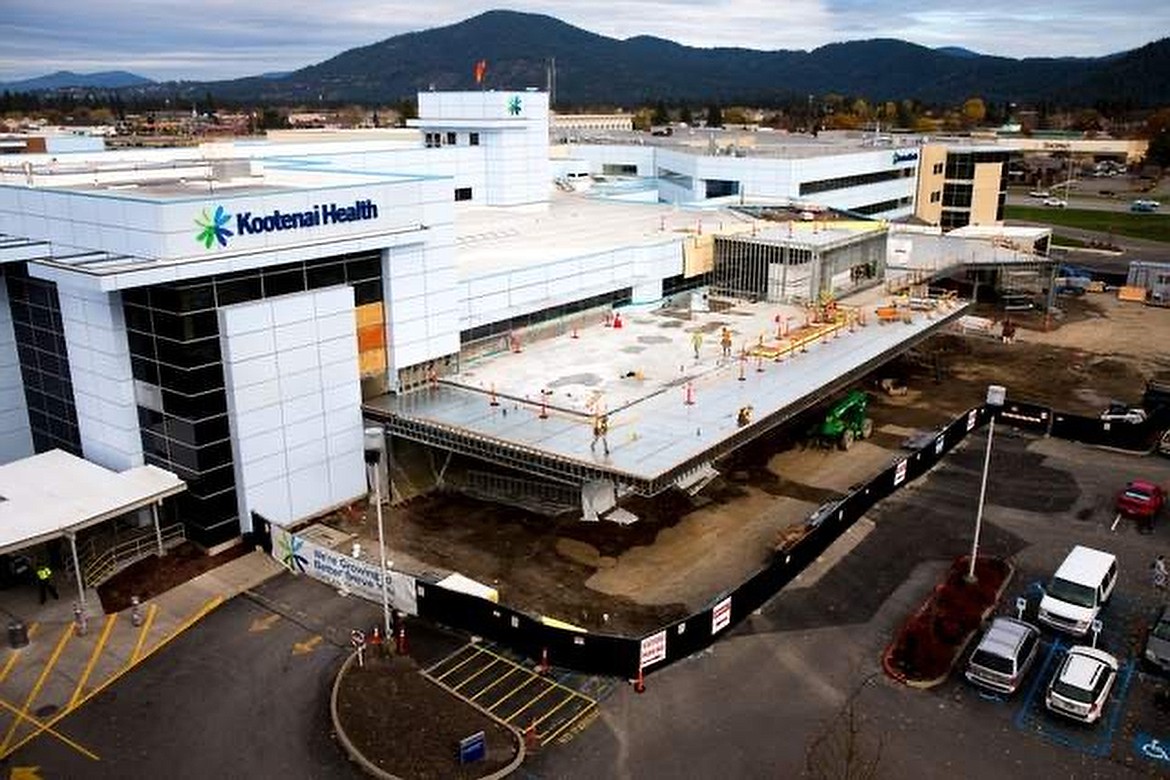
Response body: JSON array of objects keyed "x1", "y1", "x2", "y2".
[{"x1": 0, "y1": 552, "x2": 283, "y2": 759}]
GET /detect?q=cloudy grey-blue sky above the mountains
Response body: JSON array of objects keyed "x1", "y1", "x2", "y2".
[{"x1": 0, "y1": 0, "x2": 1170, "y2": 81}]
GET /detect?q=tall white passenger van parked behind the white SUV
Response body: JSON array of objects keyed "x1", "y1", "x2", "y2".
[{"x1": 1037, "y1": 545, "x2": 1117, "y2": 636}]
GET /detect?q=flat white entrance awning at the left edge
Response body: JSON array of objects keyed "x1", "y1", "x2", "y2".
[{"x1": 0, "y1": 449, "x2": 187, "y2": 553}]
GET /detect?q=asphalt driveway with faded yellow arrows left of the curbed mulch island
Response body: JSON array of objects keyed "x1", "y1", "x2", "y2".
[{"x1": 5, "y1": 574, "x2": 463, "y2": 780}]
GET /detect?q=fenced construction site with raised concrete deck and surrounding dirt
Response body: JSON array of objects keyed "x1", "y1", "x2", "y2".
[{"x1": 328, "y1": 221, "x2": 1170, "y2": 633}]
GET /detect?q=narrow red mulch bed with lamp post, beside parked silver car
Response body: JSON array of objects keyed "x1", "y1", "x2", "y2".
[{"x1": 882, "y1": 555, "x2": 1012, "y2": 683}]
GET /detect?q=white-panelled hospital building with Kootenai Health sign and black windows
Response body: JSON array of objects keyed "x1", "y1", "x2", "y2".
[{"x1": 0, "y1": 90, "x2": 931, "y2": 546}]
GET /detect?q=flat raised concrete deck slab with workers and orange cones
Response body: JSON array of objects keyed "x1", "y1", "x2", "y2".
[{"x1": 365, "y1": 288, "x2": 966, "y2": 493}]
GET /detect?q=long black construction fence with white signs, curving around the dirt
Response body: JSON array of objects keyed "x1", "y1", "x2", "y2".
[{"x1": 301, "y1": 392, "x2": 1156, "y2": 678}]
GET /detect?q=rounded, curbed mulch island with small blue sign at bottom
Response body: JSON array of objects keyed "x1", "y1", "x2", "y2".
[{"x1": 337, "y1": 653, "x2": 516, "y2": 780}]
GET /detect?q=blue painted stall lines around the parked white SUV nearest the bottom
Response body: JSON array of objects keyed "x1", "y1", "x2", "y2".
[{"x1": 1014, "y1": 640, "x2": 1135, "y2": 757}]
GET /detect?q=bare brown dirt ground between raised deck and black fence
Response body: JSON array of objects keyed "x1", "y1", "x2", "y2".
[{"x1": 329, "y1": 294, "x2": 1170, "y2": 633}]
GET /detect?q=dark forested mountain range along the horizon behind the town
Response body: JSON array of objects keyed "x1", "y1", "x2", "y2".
[{"x1": 9, "y1": 11, "x2": 1170, "y2": 106}]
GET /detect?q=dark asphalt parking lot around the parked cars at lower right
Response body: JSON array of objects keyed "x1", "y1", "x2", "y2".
[{"x1": 529, "y1": 430, "x2": 1170, "y2": 778}]
